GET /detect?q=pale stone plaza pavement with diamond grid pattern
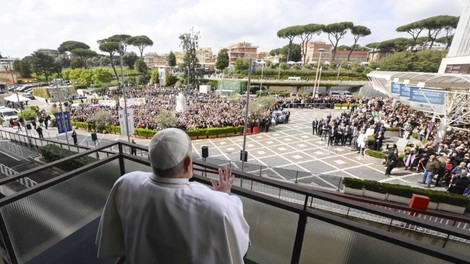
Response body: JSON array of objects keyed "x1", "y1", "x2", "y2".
[{"x1": 3, "y1": 95, "x2": 436, "y2": 192}]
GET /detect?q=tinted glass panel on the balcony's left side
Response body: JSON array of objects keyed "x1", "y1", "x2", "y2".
[{"x1": 0, "y1": 160, "x2": 120, "y2": 263}]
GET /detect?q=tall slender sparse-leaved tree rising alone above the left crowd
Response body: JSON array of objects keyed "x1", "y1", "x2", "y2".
[{"x1": 179, "y1": 29, "x2": 200, "y2": 83}]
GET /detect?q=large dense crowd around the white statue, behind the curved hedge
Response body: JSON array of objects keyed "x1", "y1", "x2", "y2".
[{"x1": 69, "y1": 87, "x2": 285, "y2": 130}]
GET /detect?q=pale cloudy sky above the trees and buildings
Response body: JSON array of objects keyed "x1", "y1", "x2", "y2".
[{"x1": 0, "y1": 0, "x2": 470, "y2": 58}]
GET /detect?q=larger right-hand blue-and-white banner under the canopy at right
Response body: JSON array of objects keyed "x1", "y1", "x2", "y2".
[{"x1": 410, "y1": 86, "x2": 446, "y2": 115}]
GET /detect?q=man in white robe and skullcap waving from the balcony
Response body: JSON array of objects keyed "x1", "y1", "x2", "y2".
[{"x1": 96, "y1": 128, "x2": 249, "y2": 264}]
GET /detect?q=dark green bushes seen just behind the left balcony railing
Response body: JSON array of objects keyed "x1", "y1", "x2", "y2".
[{"x1": 39, "y1": 144, "x2": 96, "y2": 171}]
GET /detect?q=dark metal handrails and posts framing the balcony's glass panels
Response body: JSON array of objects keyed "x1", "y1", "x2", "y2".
[{"x1": 0, "y1": 141, "x2": 470, "y2": 263}]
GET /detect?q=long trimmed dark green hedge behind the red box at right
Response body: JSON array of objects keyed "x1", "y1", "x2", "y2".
[{"x1": 343, "y1": 177, "x2": 469, "y2": 207}]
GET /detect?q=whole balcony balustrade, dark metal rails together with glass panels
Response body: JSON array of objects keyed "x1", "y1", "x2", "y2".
[{"x1": 0, "y1": 133, "x2": 470, "y2": 263}]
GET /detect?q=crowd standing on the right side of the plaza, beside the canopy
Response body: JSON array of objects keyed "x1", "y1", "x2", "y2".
[{"x1": 306, "y1": 95, "x2": 470, "y2": 194}]
